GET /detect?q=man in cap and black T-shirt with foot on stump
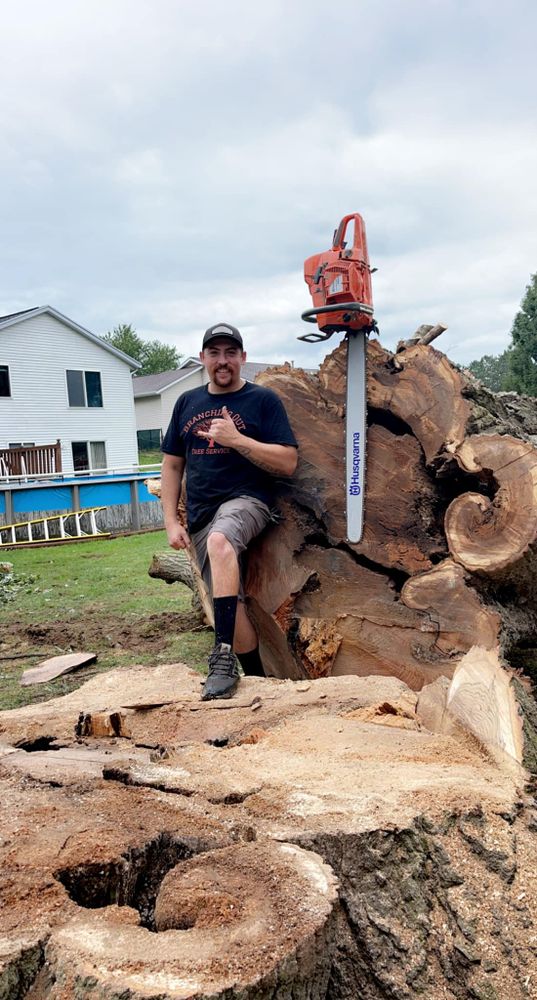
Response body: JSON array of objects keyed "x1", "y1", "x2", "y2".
[{"x1": 161, "y1": 323, "x2": 297, "y2": 701}]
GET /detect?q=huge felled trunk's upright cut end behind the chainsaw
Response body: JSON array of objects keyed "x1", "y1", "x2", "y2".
[{"x1": 149, "y1": 341, "x2": 537, "y2": 764}]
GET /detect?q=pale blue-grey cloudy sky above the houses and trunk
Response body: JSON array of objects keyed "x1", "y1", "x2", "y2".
[{"x1": 0, "y1": 0, "x2": 537, "y2": 365}]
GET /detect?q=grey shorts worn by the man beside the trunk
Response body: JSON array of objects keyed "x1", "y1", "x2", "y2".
[{"x1": 190, "y1": 497, "x2": 272, "y2": 601}]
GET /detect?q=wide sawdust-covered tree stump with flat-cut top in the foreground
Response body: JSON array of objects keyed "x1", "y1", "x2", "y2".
[{"x1": 0, "y1": 664, "x2": 537, "y2": 1000}]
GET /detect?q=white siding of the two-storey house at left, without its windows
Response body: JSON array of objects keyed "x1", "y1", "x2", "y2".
[{"x1": 0, "y1": 313, "x2": 138, "y2": 472}]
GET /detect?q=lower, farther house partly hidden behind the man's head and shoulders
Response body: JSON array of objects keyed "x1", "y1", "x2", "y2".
[{"x1": 133, "y1": 358, "x2": 275, "y2": 449}]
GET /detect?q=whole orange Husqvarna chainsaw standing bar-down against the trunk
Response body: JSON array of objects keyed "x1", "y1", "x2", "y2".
[{"x1": 298, "y1": 212, "x2": 378, "y2": 542}]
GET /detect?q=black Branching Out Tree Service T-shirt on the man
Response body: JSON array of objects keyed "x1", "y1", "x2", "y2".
[{"x1": 162, "y1": 382, "x2": 297, "y2": 531}]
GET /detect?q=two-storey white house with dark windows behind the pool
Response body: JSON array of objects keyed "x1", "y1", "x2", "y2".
[{"x1": 0, "y1": 306, "x2": 140, "y2": 474}]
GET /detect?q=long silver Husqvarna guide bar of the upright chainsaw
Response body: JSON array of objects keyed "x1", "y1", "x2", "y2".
[{"x1": 345, "y1": 330, "x2": 367, "y2": 543}]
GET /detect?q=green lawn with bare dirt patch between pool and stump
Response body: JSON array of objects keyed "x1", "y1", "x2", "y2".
[{"x1": 0, "y1": 531, "x2": 214, "y2": 709}]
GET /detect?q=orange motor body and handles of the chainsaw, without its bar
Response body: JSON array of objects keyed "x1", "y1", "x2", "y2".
[{"x1": 299, "y1": 212, "x2": 376, "y2": 342}]
